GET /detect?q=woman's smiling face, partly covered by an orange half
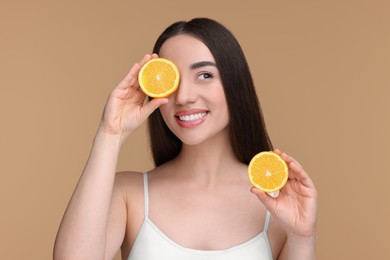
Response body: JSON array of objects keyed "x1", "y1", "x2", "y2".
[{"x1": 159, "y1": 35, "x2": 229, "y2": 145}]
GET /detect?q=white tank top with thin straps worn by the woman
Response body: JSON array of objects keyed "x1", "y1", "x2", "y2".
[{"x1": 127, "y1": 173, "x2": 272, "y2": 260}]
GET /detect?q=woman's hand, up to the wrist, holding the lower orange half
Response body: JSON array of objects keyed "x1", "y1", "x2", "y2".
[{"x1": 251, "y1": 150, "x2": 317, "y2": 238}]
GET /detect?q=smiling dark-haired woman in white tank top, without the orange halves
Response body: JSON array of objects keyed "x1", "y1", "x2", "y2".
[{"x1": 54, "y1": 18, "x2": 317, "y2": 260}]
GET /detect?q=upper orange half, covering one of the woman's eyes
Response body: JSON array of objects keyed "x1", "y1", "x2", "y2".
[{"x1": 138, "y1": 58, "x2": 180, "y2": 98}]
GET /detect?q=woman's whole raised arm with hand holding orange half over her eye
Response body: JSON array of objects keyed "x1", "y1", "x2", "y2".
[{"x1": 54, "y1": 55, "x2": 167, "y2": 259}]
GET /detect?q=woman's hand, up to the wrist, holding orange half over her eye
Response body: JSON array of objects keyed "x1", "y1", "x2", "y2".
[{"x1": 99, "y1": 54, "x2": 168, "y2": 141}]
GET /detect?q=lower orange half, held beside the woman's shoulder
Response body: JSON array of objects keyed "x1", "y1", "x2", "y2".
[{"x1": 248, "y1": 152, "x2": 288, "y2": 196}]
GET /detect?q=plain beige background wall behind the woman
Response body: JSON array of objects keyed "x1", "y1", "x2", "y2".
[{"x1": 0, "y1": 0, "x2": 390, "y2": 259}]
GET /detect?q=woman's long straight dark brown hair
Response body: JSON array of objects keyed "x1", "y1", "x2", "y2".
[{"x1": 148, "y1": 18, "x2": 272, "y2": 166}]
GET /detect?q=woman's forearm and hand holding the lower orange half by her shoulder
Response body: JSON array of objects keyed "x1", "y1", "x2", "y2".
[{"x1": 251, "y1": 150, "x2": 318, "y2": 260}]
